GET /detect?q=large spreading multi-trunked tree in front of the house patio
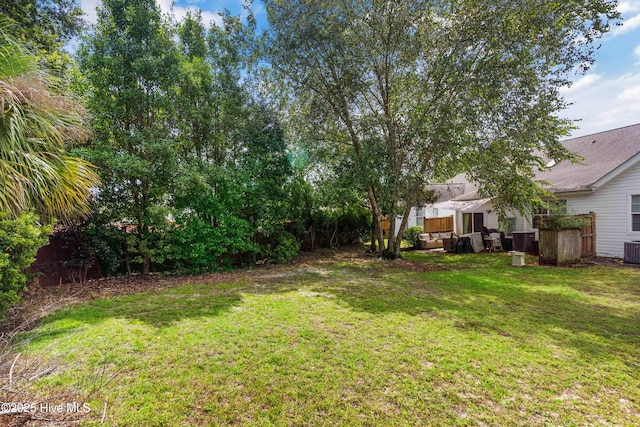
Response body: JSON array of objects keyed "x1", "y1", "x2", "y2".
[{"x1": 264, "y1": 0, "x2": 618, "y2": 258}]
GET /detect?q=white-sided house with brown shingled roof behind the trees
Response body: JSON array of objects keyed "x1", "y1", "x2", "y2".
[{"x1": 431, "y1": 124, "x2": 640, "y2": 258}]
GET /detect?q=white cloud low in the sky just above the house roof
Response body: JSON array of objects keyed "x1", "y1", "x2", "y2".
[{"x1": 562, "y1": 70, "x2": 640, "y2": 136}]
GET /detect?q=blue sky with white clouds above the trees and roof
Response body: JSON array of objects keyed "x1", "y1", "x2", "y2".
[{"x1": 80, "y1": 0, "x2": 640, "y2": 136}]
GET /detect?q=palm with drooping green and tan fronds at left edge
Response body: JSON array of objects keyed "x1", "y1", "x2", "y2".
[{"x1": 0, "y1": 25, "x2": 99, "y2": 221}]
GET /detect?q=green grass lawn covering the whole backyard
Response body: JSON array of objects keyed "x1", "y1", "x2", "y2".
[{"x1": 0, "y1": 253, "x2": 640, "y2": 426}]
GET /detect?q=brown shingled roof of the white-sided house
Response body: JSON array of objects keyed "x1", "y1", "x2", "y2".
[{"x1": 440, "y1": 123, "x2": 640, "y2": 201}]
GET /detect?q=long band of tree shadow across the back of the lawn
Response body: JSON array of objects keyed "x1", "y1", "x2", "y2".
[{"x1": 17, "y1": 255, "x2": 640, "y2": 364}]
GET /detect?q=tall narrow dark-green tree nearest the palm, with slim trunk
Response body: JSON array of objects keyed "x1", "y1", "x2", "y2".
[{"x1": 80, "y1": 0, "x2": 179, "y2": 274}]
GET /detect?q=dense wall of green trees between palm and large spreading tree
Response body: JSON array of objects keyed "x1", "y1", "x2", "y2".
[{"x1": 78, "y1": 0, "x2": 291, "y2": 273}]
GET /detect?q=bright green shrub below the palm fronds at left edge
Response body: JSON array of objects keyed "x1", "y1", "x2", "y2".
[{"x1": 0, "y1": 212, "x2": 51, "y2": 313}]
